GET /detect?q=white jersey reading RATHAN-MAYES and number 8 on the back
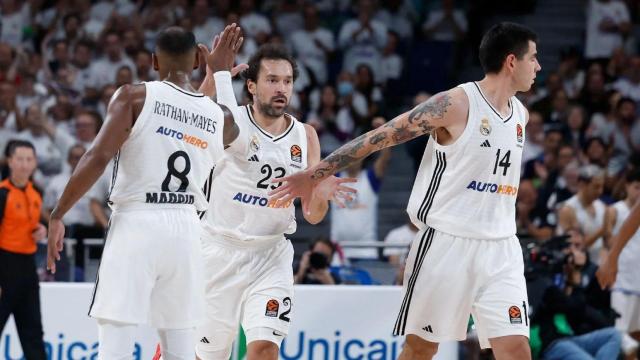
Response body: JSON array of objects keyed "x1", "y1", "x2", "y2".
[{"x1": 109, "y1": 81, "x2": 224, "y2": 210}]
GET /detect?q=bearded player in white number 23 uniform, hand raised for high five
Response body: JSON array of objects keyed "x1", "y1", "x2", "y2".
[{"x1": 196, "y1": 40, "x2": 355, "y2": 360}]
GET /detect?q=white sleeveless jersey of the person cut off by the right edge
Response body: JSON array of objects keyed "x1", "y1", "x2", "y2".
[{"x1": 612, "y1": 201, "x2": 640, "y2": 295}]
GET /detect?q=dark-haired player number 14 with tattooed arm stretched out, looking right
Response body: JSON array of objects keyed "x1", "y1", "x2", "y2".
[{"x1": 272, "y1": 23, "x2": 540, "y2": 360}]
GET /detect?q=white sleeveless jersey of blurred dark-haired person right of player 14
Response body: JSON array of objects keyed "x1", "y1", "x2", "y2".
[{"x1": 557, "y1": 195, "x2": 607, "y2": 264}]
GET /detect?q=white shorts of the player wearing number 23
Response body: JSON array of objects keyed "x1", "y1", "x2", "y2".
[{"x1": 196, "y1": 232, "x2": 293, "y2": 360}]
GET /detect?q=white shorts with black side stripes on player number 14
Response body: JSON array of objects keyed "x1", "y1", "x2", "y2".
[{"x1": 394, "y1": 228, "x2": 529, "y2": 348}]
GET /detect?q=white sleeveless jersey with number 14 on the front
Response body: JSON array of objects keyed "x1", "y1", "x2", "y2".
[{"x1": 407, "y1": 82, "x2": 526, "y2": 239}]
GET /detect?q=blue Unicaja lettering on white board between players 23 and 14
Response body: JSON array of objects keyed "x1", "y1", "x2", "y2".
[{"x1": 280, "y1": 330, "x2": 403, "y2": 360}]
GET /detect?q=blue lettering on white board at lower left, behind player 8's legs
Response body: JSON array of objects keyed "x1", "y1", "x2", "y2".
[{"x1": 0, "y1": 333, "x2": 144, "y2": 360}]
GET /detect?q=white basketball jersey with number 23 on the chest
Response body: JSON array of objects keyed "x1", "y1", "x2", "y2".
[{"x1": 203, "y1": 105, "x2": 308, "y2": 241}]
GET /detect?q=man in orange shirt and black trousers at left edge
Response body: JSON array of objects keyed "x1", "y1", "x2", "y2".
[{"x1": 0, "y1": 140, "x2": 47, "y2": 360}]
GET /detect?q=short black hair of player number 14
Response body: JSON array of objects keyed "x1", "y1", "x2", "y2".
[{"x1": 480, "y1": 22, "x2": 538, "y2": 74}]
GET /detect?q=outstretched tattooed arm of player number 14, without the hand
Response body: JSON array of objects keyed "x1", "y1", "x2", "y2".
[{"x1": 309, "y1": 88, "x2": 469, "y2": 181}]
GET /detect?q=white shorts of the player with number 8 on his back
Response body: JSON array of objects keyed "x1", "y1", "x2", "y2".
[{"x1": 89, "y1": 208, "x2": 204, "y2": 329}]
